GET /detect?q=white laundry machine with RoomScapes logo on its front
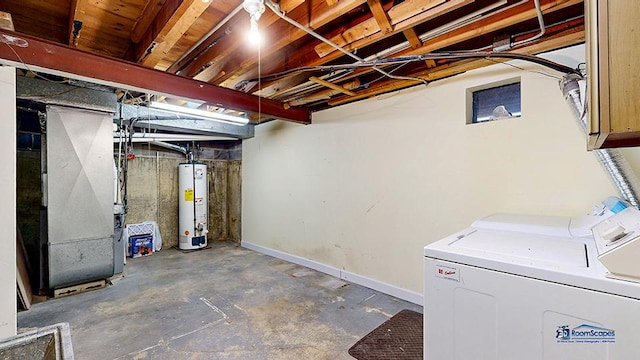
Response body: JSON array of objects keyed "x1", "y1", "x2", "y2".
[{"x1": 424, "y1": 214, "x2": 640, "y2": 360}]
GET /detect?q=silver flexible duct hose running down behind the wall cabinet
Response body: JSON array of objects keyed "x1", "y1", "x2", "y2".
[{"x1": 560, "y1": 74, "x2": 640, "y2": 208}]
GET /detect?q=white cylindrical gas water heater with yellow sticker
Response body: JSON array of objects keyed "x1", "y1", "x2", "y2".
[{"x1": 178, "y1": 162, "x2": 208, "y2": 250}]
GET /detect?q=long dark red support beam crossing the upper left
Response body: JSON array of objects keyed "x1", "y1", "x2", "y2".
[{"x1": 0, "y1": 30, "x2": 311, "y2": 124}]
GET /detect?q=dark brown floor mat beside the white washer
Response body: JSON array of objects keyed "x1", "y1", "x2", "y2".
[{"x1": 349, "y1": 310, "x2": 424, "y2": 360}]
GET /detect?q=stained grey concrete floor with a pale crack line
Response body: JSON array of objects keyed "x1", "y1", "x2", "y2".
[{"x1": 18, "y1": 243, "x2": 422, "y2": 360}]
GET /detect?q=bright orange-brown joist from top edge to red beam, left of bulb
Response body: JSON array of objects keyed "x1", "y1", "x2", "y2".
[{"x1": 138, "y1": 0, "x2": 211, "y2": 67}]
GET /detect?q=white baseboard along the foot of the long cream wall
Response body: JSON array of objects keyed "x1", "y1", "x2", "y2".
[{"x1": 241, "y1": 241, "x2": 423, "y2": 306}]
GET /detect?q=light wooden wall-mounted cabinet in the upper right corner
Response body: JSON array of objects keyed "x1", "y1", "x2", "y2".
[{"x1": 585, "y1": 0, "x2": 640, "y2": 150}]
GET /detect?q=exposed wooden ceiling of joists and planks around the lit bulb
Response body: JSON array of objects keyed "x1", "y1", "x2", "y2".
[{"x1": 0, "y1": 0, "x2": 584, "y2": 114}]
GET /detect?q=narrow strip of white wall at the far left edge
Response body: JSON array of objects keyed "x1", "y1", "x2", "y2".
[{"x1": 0, "y1": 67, "x2": 16, "y2": 339}]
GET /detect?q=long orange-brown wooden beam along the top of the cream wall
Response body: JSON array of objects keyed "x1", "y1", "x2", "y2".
[{"x1": 327, "y1": 25, "x2": 584, "y2": 106}]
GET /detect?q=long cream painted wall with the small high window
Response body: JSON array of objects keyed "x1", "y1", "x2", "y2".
[{"x1": 242, "y1": 46, "x2": 640, "y2": 294}]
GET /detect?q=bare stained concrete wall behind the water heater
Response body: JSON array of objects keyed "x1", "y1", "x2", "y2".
[{"x1": 126, "y1": 143, "x2": 242, "y2": 249}]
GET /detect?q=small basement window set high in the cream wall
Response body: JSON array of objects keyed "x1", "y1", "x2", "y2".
[{"x1": 467, "y1": 78, "x2": 522, "y2": 124}]
